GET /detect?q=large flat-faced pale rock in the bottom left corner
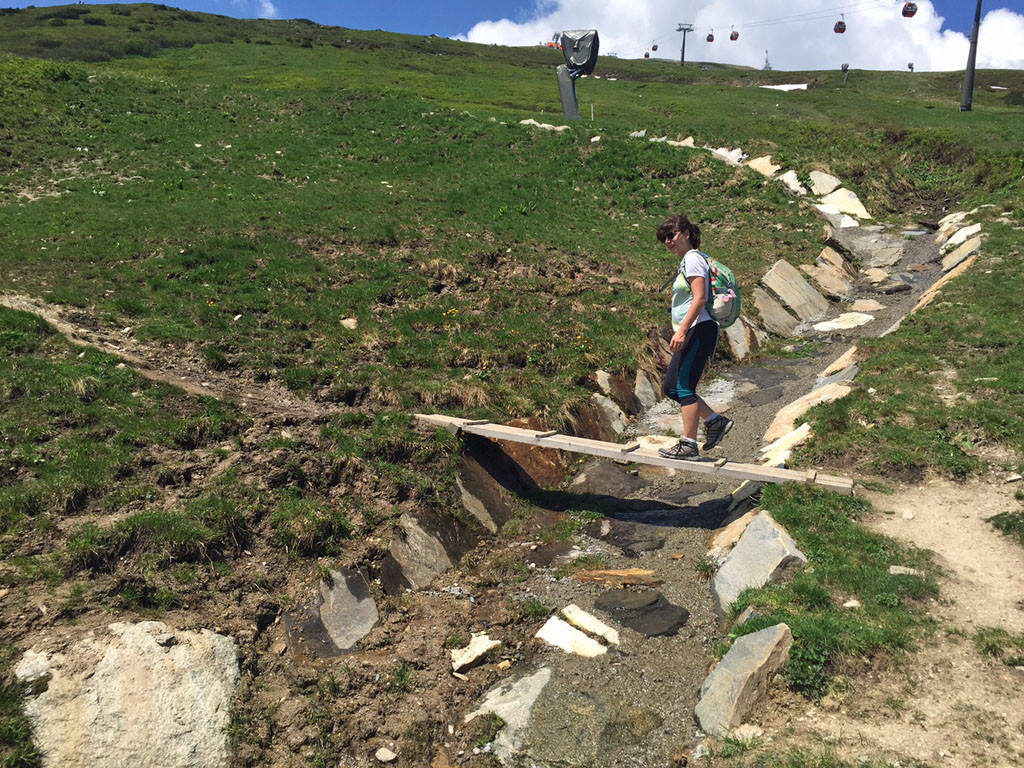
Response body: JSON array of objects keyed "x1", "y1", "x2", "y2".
[{"x1": 14, "y1": 622, "x2": 239, "y2": 768}]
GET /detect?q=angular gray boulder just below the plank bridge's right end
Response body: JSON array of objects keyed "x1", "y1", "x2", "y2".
[{"x1": 712, "y1": 512, "x2": 807, "y2": 616}]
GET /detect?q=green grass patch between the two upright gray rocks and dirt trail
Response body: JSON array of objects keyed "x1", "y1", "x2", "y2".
[{"x1": 731, "y1": 483, "x2": 938, "y2": 698}]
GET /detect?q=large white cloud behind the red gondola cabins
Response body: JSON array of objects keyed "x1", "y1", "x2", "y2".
[{"x1": 462, "y1": 0, "x2": 1024, "y2": 71}]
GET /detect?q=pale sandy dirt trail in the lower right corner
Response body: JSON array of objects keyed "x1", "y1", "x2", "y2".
[{"x1": 764, "y1": 474, "x2": 1024, "y2": 767}]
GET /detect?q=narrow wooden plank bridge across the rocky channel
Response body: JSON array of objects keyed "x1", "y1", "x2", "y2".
[{"x1": 416, "y1": 414, "x2": 853, "y2": 494}]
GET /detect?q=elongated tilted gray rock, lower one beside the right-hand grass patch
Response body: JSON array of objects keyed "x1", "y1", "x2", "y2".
[{"x1": 694, "y1": 624, "x2": 793, "y2": 737}]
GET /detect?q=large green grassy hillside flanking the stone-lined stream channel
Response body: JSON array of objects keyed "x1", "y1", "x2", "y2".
[{"x1": 0, "y1": 9, "x2": 1024, "y2": 765}]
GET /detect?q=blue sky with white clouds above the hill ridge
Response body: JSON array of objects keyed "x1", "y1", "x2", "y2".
[{"x1": 14, "y1": 0, "x2": 1024, "y2": 72}]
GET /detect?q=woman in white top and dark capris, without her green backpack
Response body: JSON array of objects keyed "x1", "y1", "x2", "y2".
[{"x1": 657, "y1": 215, "x2": 732, "y2": 459}]
